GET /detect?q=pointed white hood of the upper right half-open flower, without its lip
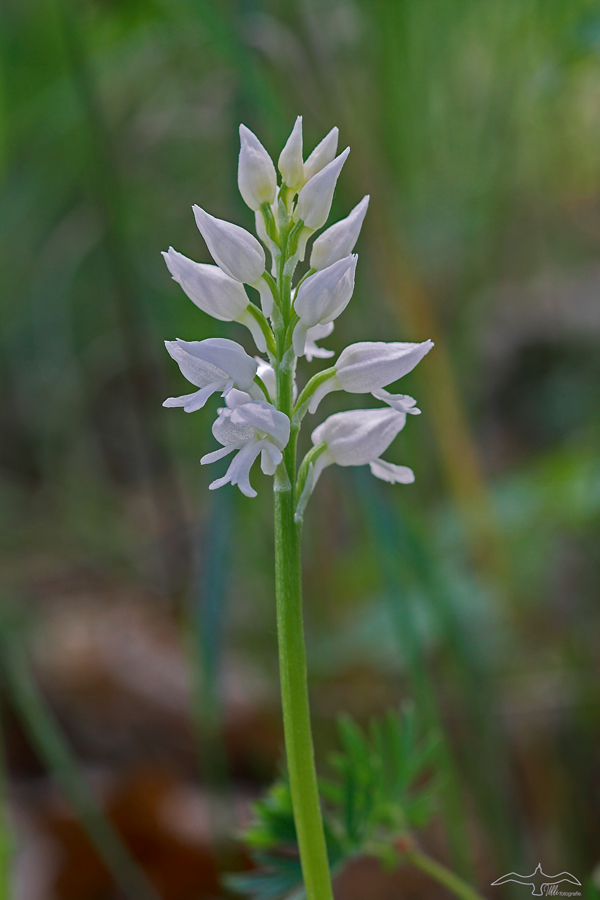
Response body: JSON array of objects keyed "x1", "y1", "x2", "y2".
[{"x1": 336, "y1": 340, "x2": 433, "y2": 394}]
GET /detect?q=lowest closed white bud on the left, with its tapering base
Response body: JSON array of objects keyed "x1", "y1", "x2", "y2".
[{"x1": 163, "y1": 247, "x2": 267, "y2": 352}]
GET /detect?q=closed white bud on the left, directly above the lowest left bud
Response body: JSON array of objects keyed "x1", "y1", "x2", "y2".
[{"x1": 192, "y1": 205, "x2": 266, "y2": 284}]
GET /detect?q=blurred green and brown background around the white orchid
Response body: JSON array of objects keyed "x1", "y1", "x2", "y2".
[{"x1": 0, "y1": 0, "x2": 600, "y2": 900}]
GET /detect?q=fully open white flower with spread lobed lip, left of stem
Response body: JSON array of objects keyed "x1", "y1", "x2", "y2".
[{"x1": 200, "y1": 400, "x2": 290, "y2": 497}]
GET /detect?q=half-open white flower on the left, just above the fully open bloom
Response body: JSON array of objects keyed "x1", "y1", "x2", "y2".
[{"x1": 163, "y1": 338, "x2": 261, "y2": 412}]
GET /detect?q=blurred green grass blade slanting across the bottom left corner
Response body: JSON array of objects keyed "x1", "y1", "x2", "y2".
[{"x1": 2, "y1": 636, "x2": 160, "y2": 900}]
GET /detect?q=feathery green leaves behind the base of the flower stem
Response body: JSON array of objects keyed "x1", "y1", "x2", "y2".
[{"x1": 226, "y1": 708, "x2": 439, "y2": 900}]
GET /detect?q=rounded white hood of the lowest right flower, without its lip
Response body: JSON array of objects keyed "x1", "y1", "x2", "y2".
[{"x1": 311, "y1": 408, "x2": 406, "y2": 466}]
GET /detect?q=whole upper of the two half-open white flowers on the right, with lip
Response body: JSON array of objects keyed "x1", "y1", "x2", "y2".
[{"x1": 309, "y1": 341, "x2": 433, "y2": 415}]
